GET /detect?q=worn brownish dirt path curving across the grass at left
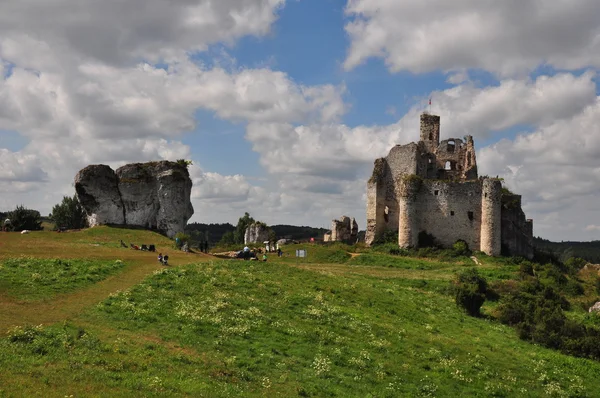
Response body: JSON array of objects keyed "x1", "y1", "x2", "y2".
[{"x1": 0, "y1": 250, "x2": 212, "y2": 334}]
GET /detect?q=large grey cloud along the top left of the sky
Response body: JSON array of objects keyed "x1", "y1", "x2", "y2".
[{"x1": 0, "y1": 0, "x2": 285, "y2": 70}]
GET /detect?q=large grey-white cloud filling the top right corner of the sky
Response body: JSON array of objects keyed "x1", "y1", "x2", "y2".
[{"x1": 345, "y1": 0, "x2": 600, "y2": 75}]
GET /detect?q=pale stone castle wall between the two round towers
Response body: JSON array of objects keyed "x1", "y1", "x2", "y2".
[{"x1": 417, "y1": 180, "x2": 481, "y2": 250}]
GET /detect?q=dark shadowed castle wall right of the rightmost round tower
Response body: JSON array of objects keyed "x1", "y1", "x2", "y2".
[{"x1": 502, "y1": 194, "x2": 534, "y2": 259}]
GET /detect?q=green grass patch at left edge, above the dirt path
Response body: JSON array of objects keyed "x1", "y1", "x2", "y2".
[{"x1": 0, "y1": 257, "x2": 125, "y2": 300}]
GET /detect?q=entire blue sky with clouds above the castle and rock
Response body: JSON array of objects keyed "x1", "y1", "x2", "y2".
[{"x1": 0, "y1": 0, "x2": 600, "y2": 240}]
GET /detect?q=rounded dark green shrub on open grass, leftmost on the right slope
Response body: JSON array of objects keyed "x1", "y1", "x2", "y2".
[{"x1": 453, "y1": 268, "x2": 487, "y2": 316}]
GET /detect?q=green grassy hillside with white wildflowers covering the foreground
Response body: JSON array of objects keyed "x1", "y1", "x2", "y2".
[{"x1": 0, "y1": 227, "x2": 600, "y2": 397}]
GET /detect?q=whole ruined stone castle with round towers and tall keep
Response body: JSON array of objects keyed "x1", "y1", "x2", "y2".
[{"x1": 365, "y1": 113, "x2": 533, "y2": 258}]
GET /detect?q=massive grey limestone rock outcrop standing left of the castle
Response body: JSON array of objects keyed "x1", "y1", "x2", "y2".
[{"x1": 75, "y1": 161, "x2": 194, "y2": 238}]
